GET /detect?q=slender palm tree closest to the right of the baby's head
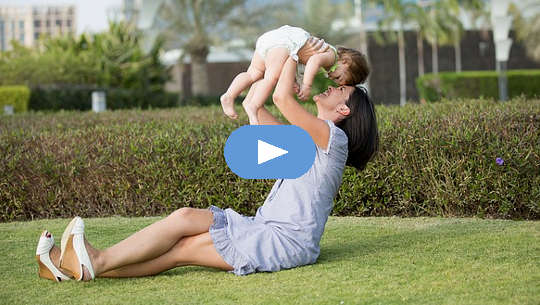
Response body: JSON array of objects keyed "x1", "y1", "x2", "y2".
[{"x1": 378, "y1": 0, "x2": 414, "y2": 106}]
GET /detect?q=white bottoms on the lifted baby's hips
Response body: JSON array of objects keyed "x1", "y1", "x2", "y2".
[{"x1": 255, "y1": 25, "x2": 311, "y2": 61}]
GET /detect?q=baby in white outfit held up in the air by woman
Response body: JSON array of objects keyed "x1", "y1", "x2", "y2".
[{"x1": 220, "y1": 25, "x2": 369, "y2": 125}]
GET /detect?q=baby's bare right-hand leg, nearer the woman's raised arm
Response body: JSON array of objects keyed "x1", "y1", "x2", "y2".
[{"x1": 242, "y1": 48, "x2": 289, "y2": 125}]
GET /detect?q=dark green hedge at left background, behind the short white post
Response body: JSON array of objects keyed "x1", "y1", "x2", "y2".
[{"x1": 29, "y1": 85, "x2": 178, "y2": 111}]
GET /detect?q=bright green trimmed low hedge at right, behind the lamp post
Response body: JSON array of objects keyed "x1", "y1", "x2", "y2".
[{"x1": 416, "y1": 70, "x2": 540, "y2": 102}]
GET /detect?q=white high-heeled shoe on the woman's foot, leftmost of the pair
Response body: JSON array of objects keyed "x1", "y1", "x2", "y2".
[{"x1": 36, "y1": 230, "x2": 70, "y2": 282}]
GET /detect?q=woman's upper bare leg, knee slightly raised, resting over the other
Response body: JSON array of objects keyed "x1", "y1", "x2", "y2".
[{"x1": 85, "y1": 208, "x2": 213, "y2": 275}]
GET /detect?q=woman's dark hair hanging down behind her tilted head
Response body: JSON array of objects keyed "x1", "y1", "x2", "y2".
[{"x1": 336, "y1": 87, "x2": 379, "y2": 170}]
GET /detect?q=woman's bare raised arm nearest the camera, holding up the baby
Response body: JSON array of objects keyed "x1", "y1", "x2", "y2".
[{"x1": 272, "y1": 57, "x2": 330, "y2": 149}]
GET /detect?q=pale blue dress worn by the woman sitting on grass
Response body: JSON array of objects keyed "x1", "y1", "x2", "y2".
[{"x1": 209, "y1": 120, "x2": 348, "y2": 275}]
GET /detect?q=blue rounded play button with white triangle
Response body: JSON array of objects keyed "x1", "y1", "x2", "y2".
[{"x1": 224, "y1": 125, "x2": 315, "y2": 179}]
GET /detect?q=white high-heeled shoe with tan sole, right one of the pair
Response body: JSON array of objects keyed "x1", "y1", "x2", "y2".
[{"x1": 60, "y1": 217, "x2": 95, "y2": 281}]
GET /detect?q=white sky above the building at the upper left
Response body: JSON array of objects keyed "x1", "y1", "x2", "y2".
[{"x1": 0, "y1": 0, "x2": 122, "y2": 34}]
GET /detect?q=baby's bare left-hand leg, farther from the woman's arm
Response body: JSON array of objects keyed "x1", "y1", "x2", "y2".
[{"x1": 220, "y1": 52, "x2": 264, "y2": 119}]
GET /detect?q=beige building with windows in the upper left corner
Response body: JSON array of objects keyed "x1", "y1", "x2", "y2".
[{"x1": 0, "y1": 5, "x2": 77, "y2": 51}]
